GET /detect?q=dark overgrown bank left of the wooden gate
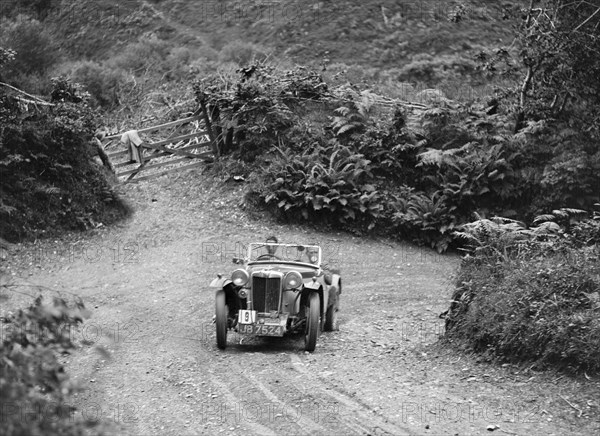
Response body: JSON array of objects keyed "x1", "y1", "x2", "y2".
[{"x1": 0, "y1": 76, "x2": 128, "y2": 242}]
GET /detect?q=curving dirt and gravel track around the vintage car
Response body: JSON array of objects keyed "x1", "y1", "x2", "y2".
[{"x1": 3, "y1": 173, "x2": 597, "y2": 435}]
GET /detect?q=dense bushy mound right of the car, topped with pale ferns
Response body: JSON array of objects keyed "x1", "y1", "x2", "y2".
[{"x1": 446, "y1": 215, "x2": 600, "y2": 371}]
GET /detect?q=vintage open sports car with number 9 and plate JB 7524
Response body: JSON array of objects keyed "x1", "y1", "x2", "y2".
[{"x1": 210, "y1": 242, "x2": 342, "y2": 351}]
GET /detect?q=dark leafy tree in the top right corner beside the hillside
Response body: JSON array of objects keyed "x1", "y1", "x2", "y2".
[{"x1": 517, "y1": 0, "x2": 600, "y2": 137}]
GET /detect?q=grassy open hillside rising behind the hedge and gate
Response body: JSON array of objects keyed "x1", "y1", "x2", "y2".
[{"x1": 3, "y1": 0, "x2": 512, "y2": 95}]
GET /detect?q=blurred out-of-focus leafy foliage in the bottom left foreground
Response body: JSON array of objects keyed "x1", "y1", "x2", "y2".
[{"x1": 0, "y1": 296, "x2": 93, "y2": 435}]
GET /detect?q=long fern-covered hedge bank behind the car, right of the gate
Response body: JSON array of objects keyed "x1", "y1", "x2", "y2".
[{"x1": 196, "y1": 64, "x2": 600, "y2": 251}]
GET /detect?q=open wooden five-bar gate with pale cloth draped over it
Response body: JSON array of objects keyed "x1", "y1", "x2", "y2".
[{"x1": 102, "y1": 114, "x2": 213, "y2": 183}]
